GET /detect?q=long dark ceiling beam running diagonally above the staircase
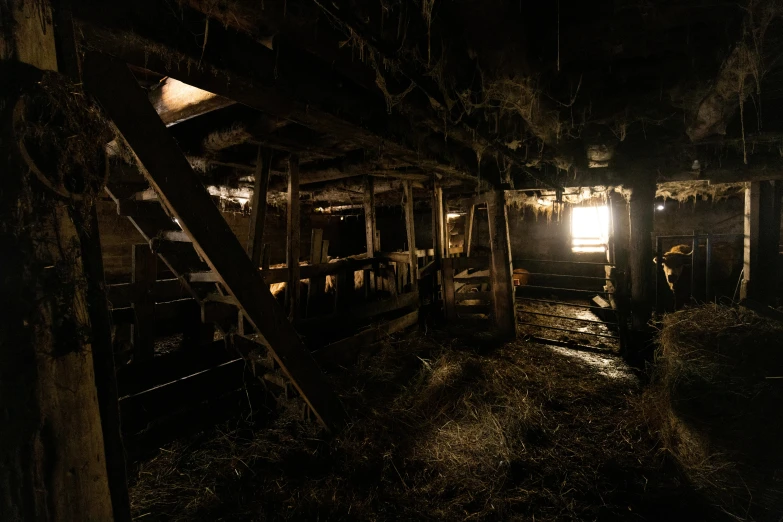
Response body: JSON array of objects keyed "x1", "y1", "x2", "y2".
[{"x1": 74, "y1": 0, "x2": 486, "y2": 188}]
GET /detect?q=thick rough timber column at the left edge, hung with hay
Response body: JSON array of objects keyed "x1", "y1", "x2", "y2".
[{"x1": 0, "y1": 0, "x2": 114, "y2": 521}]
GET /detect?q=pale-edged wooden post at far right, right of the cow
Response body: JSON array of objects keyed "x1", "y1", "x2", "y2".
[{"x1": 740, "y1": 181, "x2": 783, "y2": 305}]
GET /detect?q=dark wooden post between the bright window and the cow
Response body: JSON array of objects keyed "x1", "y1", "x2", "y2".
[{"x1": 628, "y1": 178, "x2": 655, "y2": 330}]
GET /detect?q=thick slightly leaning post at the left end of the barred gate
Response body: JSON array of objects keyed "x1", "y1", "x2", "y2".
[{"x1": 487, "y1": 190, "x2": 517, "y2": 340}]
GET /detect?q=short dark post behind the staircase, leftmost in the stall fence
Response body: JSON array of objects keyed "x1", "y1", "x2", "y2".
[{"x1": 131, "y1": 244, "x2": 158, "y2": 362}]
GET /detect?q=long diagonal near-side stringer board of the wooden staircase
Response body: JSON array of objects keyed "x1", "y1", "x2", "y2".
[{"x1": 83, "y1": 54, "x2": 345, "y2": 429}]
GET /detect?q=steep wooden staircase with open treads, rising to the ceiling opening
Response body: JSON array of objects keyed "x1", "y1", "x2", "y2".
[{"x1": 84, "y1": 54, "x2": 344, "y2": 429}]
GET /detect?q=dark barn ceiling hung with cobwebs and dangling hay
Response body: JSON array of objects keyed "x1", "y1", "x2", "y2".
[{"x1": 74, "y1": 0, "x2": 783, "y2": 205}]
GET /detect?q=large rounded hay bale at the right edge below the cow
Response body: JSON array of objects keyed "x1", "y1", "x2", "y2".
[{"x1": 647, "y1": 304, "x2": 783, "y2": 520}]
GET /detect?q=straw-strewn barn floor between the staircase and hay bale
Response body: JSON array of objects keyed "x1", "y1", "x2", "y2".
[{"x1": 131, "y1": 330, "x2": 720, "y2": 521}]
